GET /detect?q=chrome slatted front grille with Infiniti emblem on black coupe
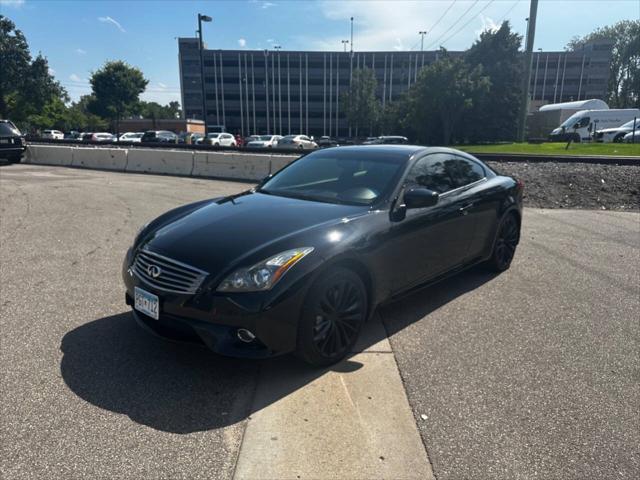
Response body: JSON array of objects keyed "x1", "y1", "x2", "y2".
[{"x1": 131, "y1": 249, "x2": 208, "y2": 294}]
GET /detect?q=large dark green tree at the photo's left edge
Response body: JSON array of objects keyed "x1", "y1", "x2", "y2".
[{"x1": 0, "y1": 15, "x2": 68, "y2": 128}]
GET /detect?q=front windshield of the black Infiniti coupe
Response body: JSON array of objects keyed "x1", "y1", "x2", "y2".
[{"x1": 260, "y1": 150, "x2": 406, "y2": 205}]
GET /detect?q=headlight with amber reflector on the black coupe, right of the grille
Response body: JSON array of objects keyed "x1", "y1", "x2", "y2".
[{"x1": 217, "y1": 247, "x2": 313, "y2": 292}]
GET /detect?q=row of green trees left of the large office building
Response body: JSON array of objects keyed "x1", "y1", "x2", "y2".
[{"x1": 0, "y1": 15, "x2": 182, "y2": 132}]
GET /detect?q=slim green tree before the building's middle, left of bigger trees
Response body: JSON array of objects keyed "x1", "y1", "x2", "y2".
[{"x1": 340, "y1": 68, "x2": 380, "y2": 136}]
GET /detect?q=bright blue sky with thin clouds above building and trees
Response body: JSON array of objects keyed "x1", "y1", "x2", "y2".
[{"x1": 0, "y1": 0, "x2": 640, "y2": 103}]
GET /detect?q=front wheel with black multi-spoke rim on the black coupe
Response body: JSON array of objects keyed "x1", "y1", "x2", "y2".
[{"x1": 296, "y1": 267, "x2": 368, "y2": 367}]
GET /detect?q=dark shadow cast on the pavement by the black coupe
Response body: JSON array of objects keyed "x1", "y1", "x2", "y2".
[{"x1": 60, "y1": 270, "x2": 493, "y2": 434}]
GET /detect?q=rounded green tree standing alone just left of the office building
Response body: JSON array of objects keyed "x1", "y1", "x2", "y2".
[{"x1": 88, "y1": 60, "x2": 149, "y2": 134}]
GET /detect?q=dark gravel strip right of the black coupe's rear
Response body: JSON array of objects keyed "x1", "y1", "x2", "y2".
[{"x1": 486, "y1": 162, "x2": 640, "y2": 210}]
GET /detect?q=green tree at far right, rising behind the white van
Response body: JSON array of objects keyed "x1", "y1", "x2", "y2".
[{"x1": 567, "y1": 20, "x2": 640, "y2": 108}]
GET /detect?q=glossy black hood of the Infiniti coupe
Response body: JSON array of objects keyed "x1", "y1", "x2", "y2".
[{"x1": 143, "y1": 192, "x2": 369, "y2": 274}]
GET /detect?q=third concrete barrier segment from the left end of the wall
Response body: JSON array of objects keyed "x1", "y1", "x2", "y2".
[{"x1": 125, "y1": 148, "x2": 194, "y2": 175}]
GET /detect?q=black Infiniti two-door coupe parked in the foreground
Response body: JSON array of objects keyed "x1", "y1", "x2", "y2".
[{"x1": 123, "y1": 145, "x2": 523, "y2": 366}]
